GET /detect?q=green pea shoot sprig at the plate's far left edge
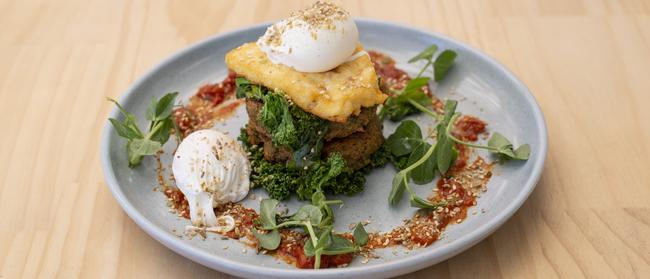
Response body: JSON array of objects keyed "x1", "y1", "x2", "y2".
[{"x1": 108, "y1": 92, "x2": 178, "y2": 167}]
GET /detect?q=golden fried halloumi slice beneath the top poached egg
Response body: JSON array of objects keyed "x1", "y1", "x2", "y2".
[{"x1": 226, "y1": 43, "x2": 387, "y2": 122}]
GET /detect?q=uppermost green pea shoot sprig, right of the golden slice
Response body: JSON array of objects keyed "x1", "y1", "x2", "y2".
[{"x1": 379, "y1": 45, "x2": 457, "y2": 121}]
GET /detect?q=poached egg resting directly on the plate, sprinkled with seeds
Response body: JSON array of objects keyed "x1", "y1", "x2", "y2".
[{"x1": 172, "y1": 130, "x2": 251, "y2": 227}]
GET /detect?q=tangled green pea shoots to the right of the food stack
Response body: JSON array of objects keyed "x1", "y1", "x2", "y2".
[{"x1": 380, "y1": 45, "x2": 530, "y2": 209}]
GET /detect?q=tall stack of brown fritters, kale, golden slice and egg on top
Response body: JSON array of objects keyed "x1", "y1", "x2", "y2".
[{"x1": 226, "y1": 2, "x2": 387, "y2": 197}]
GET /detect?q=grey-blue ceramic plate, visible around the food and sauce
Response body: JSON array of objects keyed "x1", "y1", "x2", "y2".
[{"x1": 101, "y1": 20, "x2": 547, "y2": 278}]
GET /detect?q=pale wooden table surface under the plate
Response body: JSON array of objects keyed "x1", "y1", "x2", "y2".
[{"x1": 0, "y1": 0, "x2": 650, "y2": 278}]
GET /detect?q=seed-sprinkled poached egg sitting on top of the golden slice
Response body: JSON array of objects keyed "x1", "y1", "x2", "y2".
[{"x1": 257, "y1": 1, "x2": 359, "y2": 73}]
